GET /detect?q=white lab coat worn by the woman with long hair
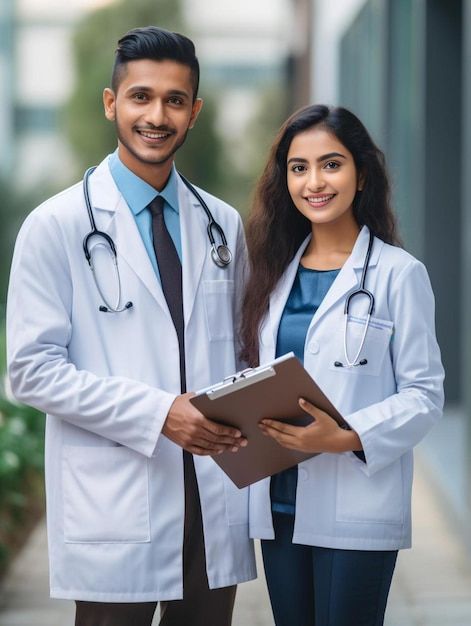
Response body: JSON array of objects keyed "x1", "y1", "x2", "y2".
[{"x1": 250, "y1": 227, "x2": 443, "y2": 550}]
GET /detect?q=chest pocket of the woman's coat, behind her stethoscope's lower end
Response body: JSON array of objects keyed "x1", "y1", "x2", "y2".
[{"x1": 329, "y1": 315, "x2": 394, "y2": 376}]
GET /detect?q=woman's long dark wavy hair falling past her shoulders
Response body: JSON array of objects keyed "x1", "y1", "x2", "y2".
[{"x1": 241, "y1": 104, "x2": 400, "y2": 366}]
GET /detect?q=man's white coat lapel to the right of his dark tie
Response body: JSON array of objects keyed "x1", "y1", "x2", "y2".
[{"x1": 178, "y1": 177, "x2": 209, "y2": 325}]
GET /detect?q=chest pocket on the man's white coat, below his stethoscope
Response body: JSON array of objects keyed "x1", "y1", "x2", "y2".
[{"x1": 203, "y1": 280, "x2": 234, "y2": 341}]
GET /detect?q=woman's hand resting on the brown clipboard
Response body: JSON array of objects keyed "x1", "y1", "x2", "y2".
[{"x1": 259, "y1": 398, "x2": 362, "y2": 453}]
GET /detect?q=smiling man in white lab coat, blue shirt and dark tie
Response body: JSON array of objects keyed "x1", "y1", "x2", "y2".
[{"x1": 8, "y1": 27, "x2": 255, "y2": 626}]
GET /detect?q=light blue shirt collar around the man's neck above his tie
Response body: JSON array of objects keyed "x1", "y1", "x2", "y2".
[{"x1": 109, "y1": 150, "x2": 179, "y2": 215}]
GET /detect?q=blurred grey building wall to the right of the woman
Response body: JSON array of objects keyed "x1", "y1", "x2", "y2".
[{"x1": 311, "y1": 0, "x2": 471, "y2": 542}]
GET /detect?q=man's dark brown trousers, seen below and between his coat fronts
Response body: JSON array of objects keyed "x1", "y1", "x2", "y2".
[{"x1": 75, "y1": 453, "x2": 236, "y2": 626}]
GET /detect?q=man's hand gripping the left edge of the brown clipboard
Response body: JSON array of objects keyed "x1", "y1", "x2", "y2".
[{"x1": 162, "y1": 393, "x2": 247, "y2": 455}]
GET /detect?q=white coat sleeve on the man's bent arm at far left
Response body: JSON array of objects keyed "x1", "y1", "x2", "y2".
[{"x1": 7, "y1": 213, "x2": 175, "y2": 456}]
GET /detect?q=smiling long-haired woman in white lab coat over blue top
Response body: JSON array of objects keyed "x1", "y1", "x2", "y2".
[{"x1": 242, "y1": 105, "x2": 443, "y2": 626}]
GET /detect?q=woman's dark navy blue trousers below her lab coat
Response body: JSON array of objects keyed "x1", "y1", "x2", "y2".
[{"x1": 262, "y1": 513, "x2": 397, "y2": 626}]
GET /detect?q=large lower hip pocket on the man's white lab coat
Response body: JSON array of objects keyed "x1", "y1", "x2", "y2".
[{"x1": 62, "y1": 446, "x2": 150, "y2": 543}]
